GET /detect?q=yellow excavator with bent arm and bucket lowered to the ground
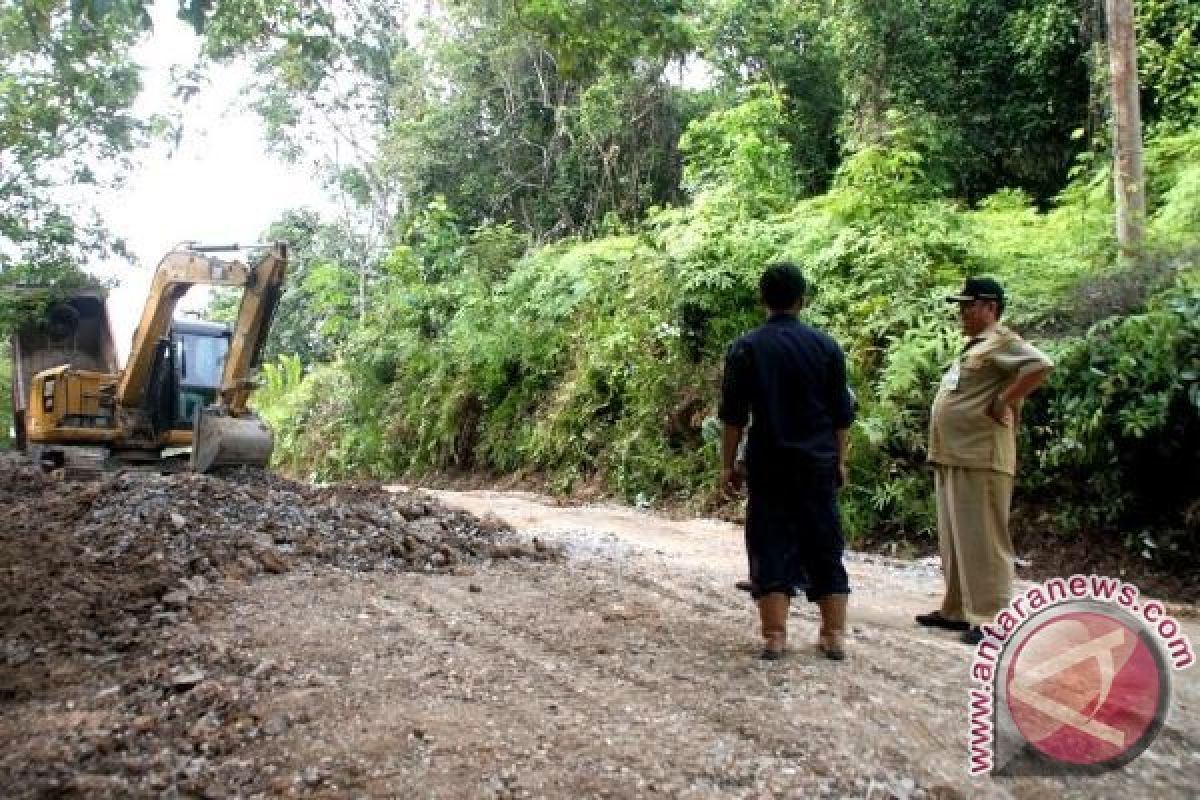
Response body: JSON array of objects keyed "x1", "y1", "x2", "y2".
[{"x1": 12, "y1": 242, "x2": 288, "y2": 477}]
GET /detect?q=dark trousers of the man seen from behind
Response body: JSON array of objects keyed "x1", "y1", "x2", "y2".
[{"x1": 745, "y1": 470, "x2": 850, "y2": 602}]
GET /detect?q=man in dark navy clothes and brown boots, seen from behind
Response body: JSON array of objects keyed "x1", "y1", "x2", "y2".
[{"x1": 718, "y1": 263, "x2": 854, "y2": 661}]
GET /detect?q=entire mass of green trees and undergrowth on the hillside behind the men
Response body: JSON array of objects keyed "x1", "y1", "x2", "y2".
[{"x1": 208, "y1": 0, "x2": 1200, "y2": 563}]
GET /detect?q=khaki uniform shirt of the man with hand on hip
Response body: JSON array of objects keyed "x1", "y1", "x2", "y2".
[{"x1": 929, "y1": 325, "x2": 1054, "y2": 475}]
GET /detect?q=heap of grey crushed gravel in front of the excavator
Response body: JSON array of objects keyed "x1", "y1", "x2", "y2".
[{"x1": 76, "y1": 470, "x2": 540, "y2": 579}]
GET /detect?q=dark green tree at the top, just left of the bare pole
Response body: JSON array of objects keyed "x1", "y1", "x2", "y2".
[{"x1": 835, "y1": 0, "x2": 1091, "y2": 204}]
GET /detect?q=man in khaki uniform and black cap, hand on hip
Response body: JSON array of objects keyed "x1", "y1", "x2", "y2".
[{"x1": 917, "y1": 278, "x2": 1054, "y2": 644}]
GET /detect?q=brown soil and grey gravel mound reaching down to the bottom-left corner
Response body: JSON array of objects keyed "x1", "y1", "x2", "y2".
[{"x1": 0, "y1": 453, "x2": 559, "y2": 796}]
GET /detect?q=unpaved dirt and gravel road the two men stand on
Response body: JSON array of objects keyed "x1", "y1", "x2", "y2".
[{"x1": 0, "y1": 479, "x2": 1200, "y2": 800}]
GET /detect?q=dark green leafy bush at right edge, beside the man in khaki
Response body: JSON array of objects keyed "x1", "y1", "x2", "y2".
[{"x1": 1028, "y1": 267, "x2": 1200, "y2": 544}]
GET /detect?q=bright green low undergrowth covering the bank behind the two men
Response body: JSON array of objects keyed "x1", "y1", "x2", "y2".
[{"x1": 259, "y1": 133, "x2": 1200, "y2": 563}]
